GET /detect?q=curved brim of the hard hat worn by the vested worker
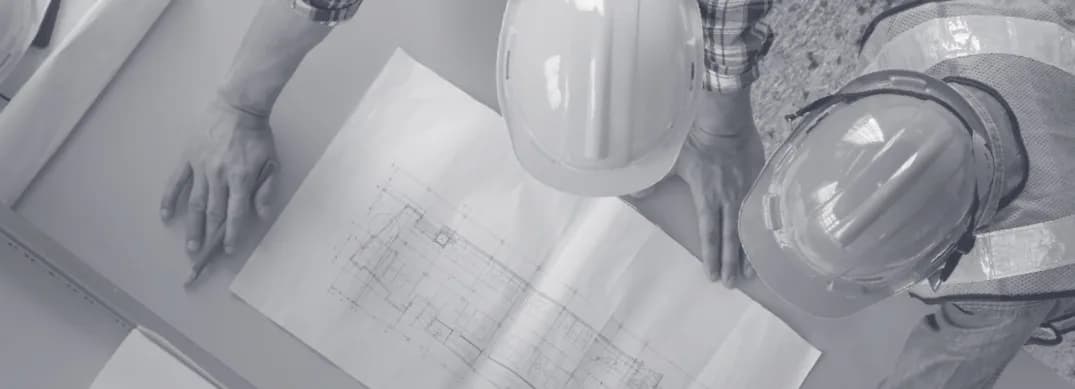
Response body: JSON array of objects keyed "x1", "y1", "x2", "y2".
[{"x1": 739, "y1": 147, "x2": 893, "y2": 318}]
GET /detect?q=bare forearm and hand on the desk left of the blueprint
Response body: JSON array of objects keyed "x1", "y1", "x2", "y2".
[{"x1": 160, "y1": 1, "x2": 332, "y2": 279}]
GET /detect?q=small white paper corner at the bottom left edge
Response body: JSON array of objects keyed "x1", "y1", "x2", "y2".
[{"x1": 89, "y1": 329, "x2": 216, "y2": 389}]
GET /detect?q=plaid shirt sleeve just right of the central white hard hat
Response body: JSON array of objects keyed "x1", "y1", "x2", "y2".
[{"x1": 698, "y1": 0, "x2": 773, "y2": 92}]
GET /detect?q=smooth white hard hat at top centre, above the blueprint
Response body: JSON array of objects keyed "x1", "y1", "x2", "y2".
[{"x1": 497, "y1": 0, "x2": 704, "y2": 196}]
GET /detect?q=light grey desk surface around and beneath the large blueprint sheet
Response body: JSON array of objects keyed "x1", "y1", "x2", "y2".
[{"x1": 10, "y1": 0, "x2": 1065, "y2": 389}]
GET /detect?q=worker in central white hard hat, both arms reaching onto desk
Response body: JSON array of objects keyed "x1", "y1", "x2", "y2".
[{"x1": 160, "y1": 0, "x2": 772, "y2": 287}]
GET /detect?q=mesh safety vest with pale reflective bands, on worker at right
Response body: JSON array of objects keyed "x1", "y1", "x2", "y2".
[{"x1": 863, "y1": 0, "x2": 1075, "y2": 303}]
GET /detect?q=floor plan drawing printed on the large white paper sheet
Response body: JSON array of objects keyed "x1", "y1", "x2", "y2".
[{"x1": 316, "y1": 167, "x2": 705, "y2": 389}]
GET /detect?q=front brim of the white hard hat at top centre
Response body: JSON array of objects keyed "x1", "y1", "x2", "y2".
[{"x1": 507, "y1": 117, "x2": 692, "y2": 197}]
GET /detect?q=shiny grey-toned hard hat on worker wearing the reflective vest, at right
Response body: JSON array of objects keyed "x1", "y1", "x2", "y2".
[{"x1": 739, "y1": 70, "x2": 989, "y2": 317}]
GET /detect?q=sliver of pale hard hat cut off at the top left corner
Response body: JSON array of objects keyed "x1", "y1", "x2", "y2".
[{"x1": 0, "y1": 0, "x2": 43, "y2": 85}]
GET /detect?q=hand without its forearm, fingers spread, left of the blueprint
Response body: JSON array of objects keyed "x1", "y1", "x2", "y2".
[{"x1": 160, "y1": 101, "x2": 277, "y2": 255}]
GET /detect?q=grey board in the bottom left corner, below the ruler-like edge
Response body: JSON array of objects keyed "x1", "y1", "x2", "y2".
[{"x1": 0, "y1": 207, "x2": 253, "y2": 389}]
